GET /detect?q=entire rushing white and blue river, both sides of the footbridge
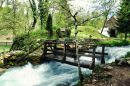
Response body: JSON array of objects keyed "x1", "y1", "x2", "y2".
[{"x1": 0, "y1": 46, "x2": 130, "y2": 86}]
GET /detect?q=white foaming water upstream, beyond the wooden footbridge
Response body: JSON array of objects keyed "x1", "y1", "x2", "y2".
[{"x1": 80, "y1": 45, "x2": 130, "y2": 63}]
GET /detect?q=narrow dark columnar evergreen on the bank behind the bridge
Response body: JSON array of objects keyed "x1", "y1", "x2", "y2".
[{"x1": 46, "y1": 14, "x2": 53, "y2": 37}]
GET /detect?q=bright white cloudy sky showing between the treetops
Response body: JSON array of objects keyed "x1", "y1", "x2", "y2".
[{"x1": 2, "y1": 0, "x2": 120, "y2": 19}]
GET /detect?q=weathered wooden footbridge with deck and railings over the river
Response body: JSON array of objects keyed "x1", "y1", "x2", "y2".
[{"x1": 41, "y1": 40, "x2": 108, "y2": 69}]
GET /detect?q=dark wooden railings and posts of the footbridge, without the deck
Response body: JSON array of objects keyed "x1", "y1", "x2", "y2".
[{"x1": 43, "y1": 40, "x2": 108, "y2": 68}]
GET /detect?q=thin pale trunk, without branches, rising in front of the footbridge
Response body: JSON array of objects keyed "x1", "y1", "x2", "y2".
[{"x1": 74, "y1": 17, "x2": 83, "y2": 85}]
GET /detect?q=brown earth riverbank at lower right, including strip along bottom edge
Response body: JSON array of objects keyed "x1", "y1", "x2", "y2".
[{"x1": 84, "y1": 66, "x2": 130, "y2": 86}]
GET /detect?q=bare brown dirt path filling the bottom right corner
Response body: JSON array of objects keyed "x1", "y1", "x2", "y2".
[{"x1": 108, "y1": 66, "x2": 130, "y2": 86}]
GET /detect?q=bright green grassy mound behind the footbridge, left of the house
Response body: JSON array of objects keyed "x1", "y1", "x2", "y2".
[{"x1": 70, "y1": 26, "x2": 106, "y2": 38}]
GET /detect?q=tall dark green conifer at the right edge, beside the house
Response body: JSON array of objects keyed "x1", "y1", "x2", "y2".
[{"x1": 117, "y1": 0, "x2": 130, "y2": 39}]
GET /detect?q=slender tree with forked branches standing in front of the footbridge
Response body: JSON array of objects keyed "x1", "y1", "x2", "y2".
[{"x1": 55, "y1": 0, "x2": 102, "y2": 84}]
